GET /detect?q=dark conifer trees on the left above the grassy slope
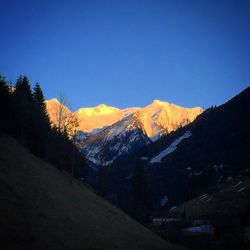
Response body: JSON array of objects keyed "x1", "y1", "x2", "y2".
[{"x1": 0, "y1": 75, "x2": 84, "y2": 178}]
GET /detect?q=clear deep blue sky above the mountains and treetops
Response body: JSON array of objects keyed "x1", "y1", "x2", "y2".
[{"x1": 0, "y1": 0, "x2": 250, "y2": 110}]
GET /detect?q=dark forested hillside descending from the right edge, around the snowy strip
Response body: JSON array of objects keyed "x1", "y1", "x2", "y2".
[{"x1": 140, "y1": 88, "x2": 250, "y2": 205}]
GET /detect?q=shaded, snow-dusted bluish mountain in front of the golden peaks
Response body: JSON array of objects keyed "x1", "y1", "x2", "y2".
[{"x1": 79, "y1": 114, "x2": 151, "y2": 166}]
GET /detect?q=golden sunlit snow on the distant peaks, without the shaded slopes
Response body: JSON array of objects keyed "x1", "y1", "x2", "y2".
[{"x1": 46, "y1": 99, "x2": 203, "y2": 138}]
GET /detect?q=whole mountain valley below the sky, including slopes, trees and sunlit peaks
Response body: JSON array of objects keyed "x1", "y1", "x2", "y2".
[{"x1": 0, "y1": 76, "x2": 250, "y2": 250}]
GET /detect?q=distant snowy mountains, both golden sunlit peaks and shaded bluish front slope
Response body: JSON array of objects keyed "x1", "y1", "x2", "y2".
[{"x1": 46, "y1": 99, "x2": 203, "y2": 165}]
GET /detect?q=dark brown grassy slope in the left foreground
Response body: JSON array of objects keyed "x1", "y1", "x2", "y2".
[{"x1": 0, "y1": 136, "x2": 184, "y2": 250}]
